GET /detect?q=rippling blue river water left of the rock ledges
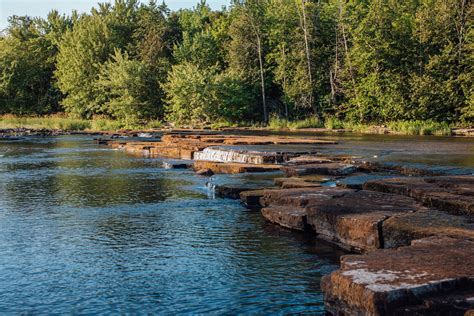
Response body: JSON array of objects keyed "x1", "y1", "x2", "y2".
[{"x1": 0, "y1": 136, "x2": 341, "y2": 314}]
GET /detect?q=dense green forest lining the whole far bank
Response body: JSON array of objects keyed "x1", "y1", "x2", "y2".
[{"x1": 0, "y1": 0, "x2": 474, "y2": 124}]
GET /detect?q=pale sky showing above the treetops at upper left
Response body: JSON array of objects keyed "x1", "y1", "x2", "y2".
[{"x1": 0, "y1": 0, "x2": 229, "y2": 30}]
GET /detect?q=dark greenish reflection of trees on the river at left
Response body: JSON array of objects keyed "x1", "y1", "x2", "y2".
[{"x1": 2, "y1": 138, "x2": 206, "y2": 210}]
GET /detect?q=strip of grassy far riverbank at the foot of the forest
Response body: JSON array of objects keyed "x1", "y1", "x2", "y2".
[{"x1": 0, "y1": 115, "x2": 474, "y2": 136}]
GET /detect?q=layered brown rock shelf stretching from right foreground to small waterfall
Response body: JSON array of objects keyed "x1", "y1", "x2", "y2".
[{"x1": 97, "y1": 131, "x2": 474, "y2": 315}]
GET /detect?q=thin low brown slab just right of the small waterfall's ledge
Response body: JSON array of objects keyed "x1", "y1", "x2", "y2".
[{"x1": 282, "y1": 162, "x2": 357, "y2": 177}]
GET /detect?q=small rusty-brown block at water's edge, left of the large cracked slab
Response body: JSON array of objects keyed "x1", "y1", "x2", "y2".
[{"x1": 261, "y1": 206, "x2": 306, "y2": 231}]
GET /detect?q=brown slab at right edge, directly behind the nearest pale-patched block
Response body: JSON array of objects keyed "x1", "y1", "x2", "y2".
[{"x1": 382, "y1": 209, "x2": 474, "y2": 248}]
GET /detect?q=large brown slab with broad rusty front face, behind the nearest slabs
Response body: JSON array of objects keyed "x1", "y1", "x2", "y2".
[{"x1": 307, "y1": 191, "x2": 425, "y2": 252}]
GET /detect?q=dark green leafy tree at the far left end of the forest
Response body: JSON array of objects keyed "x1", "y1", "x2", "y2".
[{"x1": 0, "y1": 16, "x2": 60, "y2": 114}]
